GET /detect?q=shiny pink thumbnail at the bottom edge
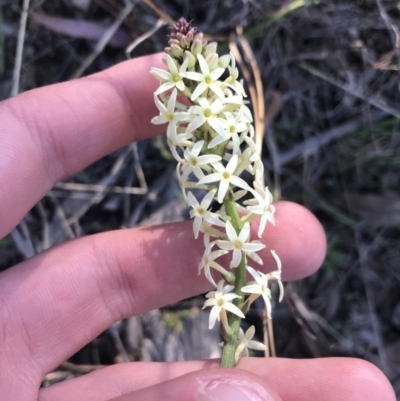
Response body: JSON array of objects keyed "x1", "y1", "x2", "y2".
[{"x1": 197, "y1": 378, "x2": 274, "y2": 401}]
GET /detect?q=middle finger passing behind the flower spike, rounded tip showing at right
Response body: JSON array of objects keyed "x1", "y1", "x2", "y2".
[{"x1": 0, "y1": 202, "x2": 325, "y2": 376}]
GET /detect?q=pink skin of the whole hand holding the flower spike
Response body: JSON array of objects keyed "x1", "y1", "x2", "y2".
[{"x1": 0, "y1": 55, "x2": 395, "y2": 401}]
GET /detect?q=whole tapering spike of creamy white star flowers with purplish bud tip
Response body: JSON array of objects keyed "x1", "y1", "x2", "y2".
[{"x1": 150, "y1": 18, "x2": 283, "y2": 366}]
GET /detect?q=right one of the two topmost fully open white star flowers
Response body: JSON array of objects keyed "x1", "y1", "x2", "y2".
[{"x1": 184, "y1": 53, "x2": 225, "y2": 101}]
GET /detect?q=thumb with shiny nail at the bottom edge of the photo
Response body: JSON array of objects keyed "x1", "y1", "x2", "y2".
[{"x1": 112, "y1": 368, "x2": 282, "y2": 401}]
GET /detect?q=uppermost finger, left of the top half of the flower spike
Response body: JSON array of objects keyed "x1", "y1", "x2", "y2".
[{"x1": 0, "y1": 55, "x2": 164, "y2": 238}]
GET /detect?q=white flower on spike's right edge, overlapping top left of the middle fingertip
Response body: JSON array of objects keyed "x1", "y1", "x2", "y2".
[{"x1": 243, "y1": 182, "x2": 275, "y2": 238}]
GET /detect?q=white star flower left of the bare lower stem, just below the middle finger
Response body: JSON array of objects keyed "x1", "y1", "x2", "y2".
[{"x1": 202, "y1": 280, "x2": 245, "y2": 333}]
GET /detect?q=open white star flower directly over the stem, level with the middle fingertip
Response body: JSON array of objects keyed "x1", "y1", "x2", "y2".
[{"x1": 217, "y1": 221, "x2": 265, "y2": 268}]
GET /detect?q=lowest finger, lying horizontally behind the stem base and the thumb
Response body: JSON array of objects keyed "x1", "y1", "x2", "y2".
[{"x1": 39, "y1": 358, "x2": 396, "y2": 401}]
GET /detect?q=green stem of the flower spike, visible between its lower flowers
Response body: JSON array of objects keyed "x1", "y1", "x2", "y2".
[{"x1": 221, "y1": 193, "x2": 246, "y2": 368}]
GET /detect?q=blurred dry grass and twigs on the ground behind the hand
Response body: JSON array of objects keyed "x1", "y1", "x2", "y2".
[{"x1": 0, "y1": 0, "x2": 400, "y2": 396}]
